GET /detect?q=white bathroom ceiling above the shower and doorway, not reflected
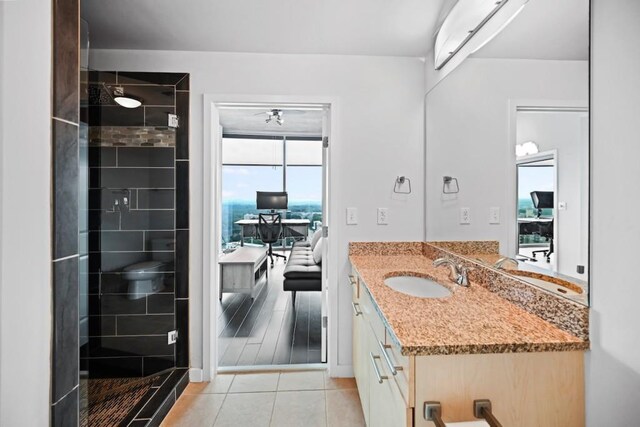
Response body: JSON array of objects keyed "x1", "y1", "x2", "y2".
[{"x1": 82, "y1": 0, "x2": 444, "y2": 57}]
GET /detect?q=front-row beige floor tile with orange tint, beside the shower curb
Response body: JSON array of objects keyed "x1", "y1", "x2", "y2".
[{"x1": 162, "y1": 394, "x2": 225, "y2": 427}]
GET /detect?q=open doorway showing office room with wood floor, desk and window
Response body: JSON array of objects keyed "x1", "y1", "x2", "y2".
[{"x1": 211, "y1": 103, "x2": 330, "y2": 372}]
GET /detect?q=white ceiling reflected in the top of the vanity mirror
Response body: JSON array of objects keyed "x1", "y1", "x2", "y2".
[{"x1": 472, "y1": 0, "x2": 589, "y2": 60}]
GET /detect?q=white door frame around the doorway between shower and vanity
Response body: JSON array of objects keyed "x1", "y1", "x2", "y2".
[{"x1": 202, "y1": 94, "x2": 339, "y2": 381}]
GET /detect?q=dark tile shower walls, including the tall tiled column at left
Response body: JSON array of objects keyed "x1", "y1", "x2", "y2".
[{"x1": 50, "y1": 5, "x2": 189, "y2": 427}]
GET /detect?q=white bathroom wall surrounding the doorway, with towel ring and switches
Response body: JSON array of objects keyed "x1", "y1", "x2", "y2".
[{"x1": 90, "y1": 50, "x2": 424, "y2": 372}]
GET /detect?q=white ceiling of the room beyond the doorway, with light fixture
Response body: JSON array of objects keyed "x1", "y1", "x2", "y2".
[{"x1": 220, "y1": 106, "x2": 324, "y2": 136}]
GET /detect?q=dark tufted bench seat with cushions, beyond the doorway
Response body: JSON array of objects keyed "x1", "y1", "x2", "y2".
[{"x1": 283, "y1": 241, "x2": 322, "y2": 304}]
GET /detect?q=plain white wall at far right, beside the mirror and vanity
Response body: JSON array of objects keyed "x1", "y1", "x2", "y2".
[{"x1": 586, "y1": 0, "x2": 640, "y2": 427}]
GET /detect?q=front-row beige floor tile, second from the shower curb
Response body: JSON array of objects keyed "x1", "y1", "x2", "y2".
[{"x1": 215, "y1": 393, "x2": 276, "y2": 427}]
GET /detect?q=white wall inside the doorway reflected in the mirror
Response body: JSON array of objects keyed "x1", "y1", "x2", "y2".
[{"x1": 516, "y1": 111, "x2": 589, "y2": 280}]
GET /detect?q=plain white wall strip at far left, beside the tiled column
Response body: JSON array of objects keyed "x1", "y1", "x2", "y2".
[{"x1": 0, "y1": 0, "x2": 51, "y2": 426}]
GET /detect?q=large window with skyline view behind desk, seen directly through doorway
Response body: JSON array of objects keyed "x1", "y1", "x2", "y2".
[{"x1": 221, "y1": 136, "x2": 322, "y2": 251}]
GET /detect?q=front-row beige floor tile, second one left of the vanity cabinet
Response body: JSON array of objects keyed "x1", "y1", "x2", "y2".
[{"x1": 271, "y1": 390, "x2": 333, "y2": 427}]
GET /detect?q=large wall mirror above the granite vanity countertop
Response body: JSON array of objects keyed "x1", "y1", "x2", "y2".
[{"x1": 425, "y1": 0, "x2": 589, "y2": 305}]
